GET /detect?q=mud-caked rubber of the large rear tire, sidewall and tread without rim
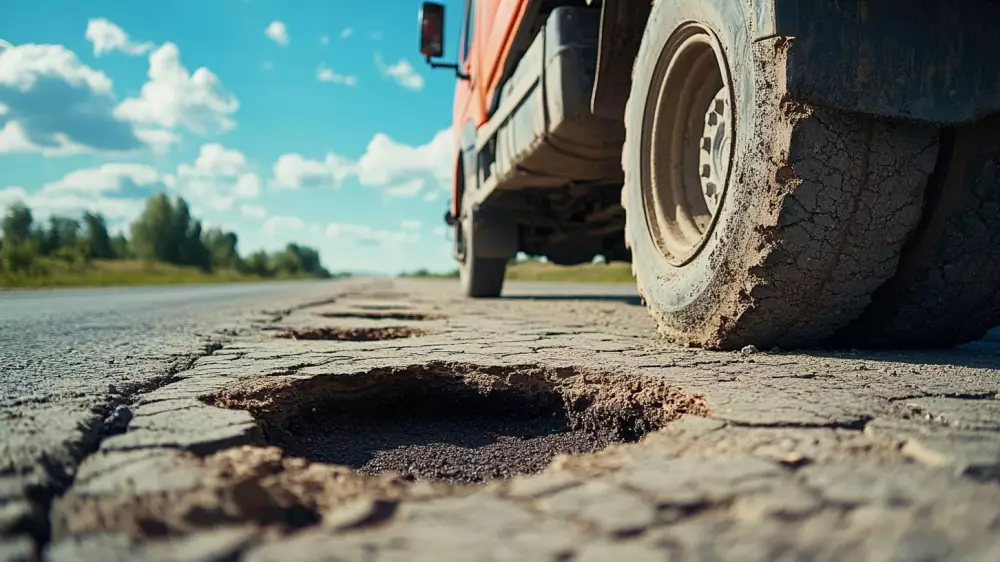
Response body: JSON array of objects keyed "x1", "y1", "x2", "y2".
[{"x1": 622, "y1": 0, "x2": 938, "y2": 348}]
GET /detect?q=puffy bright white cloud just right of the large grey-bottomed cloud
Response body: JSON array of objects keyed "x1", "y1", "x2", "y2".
[{"x1": 115, "y1": 43, "x2": 240, "y2": 134}]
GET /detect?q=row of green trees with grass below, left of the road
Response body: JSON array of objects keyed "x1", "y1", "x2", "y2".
[{"x1": 0, "y1": 194, "x2": 330, "y2": 286}]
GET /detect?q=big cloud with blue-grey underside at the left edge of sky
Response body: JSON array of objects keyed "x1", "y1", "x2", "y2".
[{"x1": 0, "y1": 43, "x2": 145, "y2": 156}]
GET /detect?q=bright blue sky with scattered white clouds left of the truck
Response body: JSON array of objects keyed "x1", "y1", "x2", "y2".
[{"x1": 0, "y1": 0, "x2": 462, "y2": 273}]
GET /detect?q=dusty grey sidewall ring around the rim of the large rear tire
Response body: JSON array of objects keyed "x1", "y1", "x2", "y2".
[{"x1": 623, "y1": 0, "x2": 760, "y2": 333}]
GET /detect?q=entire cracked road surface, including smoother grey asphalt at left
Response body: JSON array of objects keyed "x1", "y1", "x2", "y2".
[{"x1": 0, "y1": 279, "x2": 1000, "y2": 562}]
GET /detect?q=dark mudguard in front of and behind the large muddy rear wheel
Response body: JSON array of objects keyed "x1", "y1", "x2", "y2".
[{"x1": 591, "y1": 0, "x2": 1000, "y2": 126}]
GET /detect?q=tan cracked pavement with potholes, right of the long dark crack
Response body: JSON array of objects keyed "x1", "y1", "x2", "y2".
[{"x1": 0, "y1": 280, "x2": 1000, "y2": 562}]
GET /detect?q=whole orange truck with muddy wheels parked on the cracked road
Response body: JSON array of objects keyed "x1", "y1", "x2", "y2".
[{"x1": 420, "y1": 0, "x2": 1000, "y2": 349}]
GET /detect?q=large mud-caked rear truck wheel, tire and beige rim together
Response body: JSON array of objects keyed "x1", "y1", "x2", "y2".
[{"x1": 622, "y1": 0, "x2": 938, "y2": 349}]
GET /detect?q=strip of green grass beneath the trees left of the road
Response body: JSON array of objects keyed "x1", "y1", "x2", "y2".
[{"x1": 0, "y1": 258, "x2": 278, "y2": 288}]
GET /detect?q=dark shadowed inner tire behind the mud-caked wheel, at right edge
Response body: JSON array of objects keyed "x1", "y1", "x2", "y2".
[{"x1": 839, "y1": 115, "x2": 1000, "y2": 347}]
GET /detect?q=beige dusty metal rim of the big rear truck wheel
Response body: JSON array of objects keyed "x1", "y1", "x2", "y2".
[{"x1": 640, "y1": 23, "x2": 735, "y2": 266}]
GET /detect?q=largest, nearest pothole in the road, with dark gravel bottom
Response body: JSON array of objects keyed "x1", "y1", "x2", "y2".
[{"x1": 207, "y1": 363, "x2": 708, "y2": 483}]
